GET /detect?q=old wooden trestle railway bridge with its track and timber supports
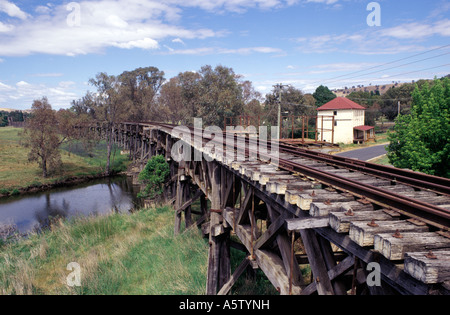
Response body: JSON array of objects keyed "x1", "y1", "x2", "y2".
[{"x1": 110, "y1": 123, "x2": 450, "y2": 295}]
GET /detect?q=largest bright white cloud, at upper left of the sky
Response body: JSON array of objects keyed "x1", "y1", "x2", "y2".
[{"x1": 0, "y1": 0, "x2": 221, "y2": 56}]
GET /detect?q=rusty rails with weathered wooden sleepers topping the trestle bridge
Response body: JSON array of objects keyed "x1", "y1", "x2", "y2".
[{"x1": 118, "y1": 122, "x2": 450, "y2": 290}]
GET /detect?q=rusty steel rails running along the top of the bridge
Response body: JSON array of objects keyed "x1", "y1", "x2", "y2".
[{"x1": 137, "y1": 122, "x2": 450, "y2": 231}]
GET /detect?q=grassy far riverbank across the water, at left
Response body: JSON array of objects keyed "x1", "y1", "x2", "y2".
[{"x1": 0, "y1": 127, "x2": 129, "y2": 198}]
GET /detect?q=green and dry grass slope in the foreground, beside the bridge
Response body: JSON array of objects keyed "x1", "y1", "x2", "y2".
[{"x1": 0, "y1": 207, "x2": 208, "y2": 295}]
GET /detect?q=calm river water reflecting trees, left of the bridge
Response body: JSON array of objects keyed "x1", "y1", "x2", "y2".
[{"x1": 0, "y1": 176, "x2": 139, "y2": 233}]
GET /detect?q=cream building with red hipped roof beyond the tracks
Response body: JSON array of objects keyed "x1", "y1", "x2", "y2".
[{"x1": 317, "y1": 97, "x2": 375, "y2": 144}]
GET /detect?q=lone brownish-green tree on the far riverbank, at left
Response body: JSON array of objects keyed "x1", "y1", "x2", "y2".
[{"x1": 23, "y1": 97, "x2": 66, "y2": 177}]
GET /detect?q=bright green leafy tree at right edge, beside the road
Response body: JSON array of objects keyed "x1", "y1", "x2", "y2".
[{"x1": 388, "y1": 78, "x2": 450, "y2": 178}]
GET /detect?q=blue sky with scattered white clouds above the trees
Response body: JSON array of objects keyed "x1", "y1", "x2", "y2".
[{"x1": 0, "y1": 0, "x2": 450, "y2": 110}]
